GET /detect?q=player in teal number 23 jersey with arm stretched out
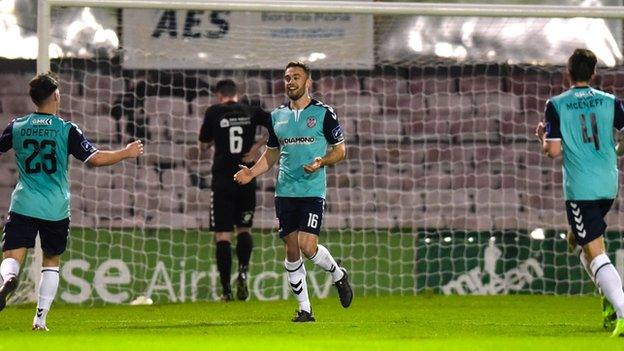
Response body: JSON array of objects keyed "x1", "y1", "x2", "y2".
[{"x1": 0, "y1": 74, "x2": 143, "y2": 331}]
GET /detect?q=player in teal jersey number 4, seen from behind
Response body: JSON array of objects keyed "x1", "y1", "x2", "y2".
[{"x1": 536, "y1": 49, "x2": 624, "y2": 336}]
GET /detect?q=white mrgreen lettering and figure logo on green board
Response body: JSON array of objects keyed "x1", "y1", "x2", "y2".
[{"x1": 442, "y1": 242, "x2": 544, "y2": 295}]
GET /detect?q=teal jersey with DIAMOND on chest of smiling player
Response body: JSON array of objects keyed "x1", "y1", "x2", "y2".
[{"x1": 267, "y1": 99, "x2": 344, "y2": 198}]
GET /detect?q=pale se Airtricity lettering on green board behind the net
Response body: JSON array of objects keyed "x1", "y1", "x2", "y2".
[{"x1": 60, "y1": 259, "x2": 333, "y2": 303}]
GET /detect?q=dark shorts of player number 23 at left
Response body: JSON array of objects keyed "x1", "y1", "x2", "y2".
[{"x1": 2, "y1": 212, "x2": 69, "y2": 256}]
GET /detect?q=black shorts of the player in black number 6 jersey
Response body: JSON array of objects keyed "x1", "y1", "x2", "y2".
[{"x1": 210, "y1": 178, "x2": 256, "y2": 232}]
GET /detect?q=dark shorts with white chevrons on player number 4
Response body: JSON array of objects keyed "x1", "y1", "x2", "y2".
[{"x1": 566, "y1": 199, "x2": 613, "y2": 246}]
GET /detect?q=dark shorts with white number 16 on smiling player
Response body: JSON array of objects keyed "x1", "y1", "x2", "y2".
[{"x1": 275, "y1": 197, "x2": 325, "y2": 238}]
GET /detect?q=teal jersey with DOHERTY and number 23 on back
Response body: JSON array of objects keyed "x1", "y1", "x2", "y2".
[{"x1": 0, "y1": 113, "x2": 97, "y2": 221}]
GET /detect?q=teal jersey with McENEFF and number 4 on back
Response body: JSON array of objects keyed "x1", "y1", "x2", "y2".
[{"x1": 545, "y1": 87, "x2": 624, "y2": 201}]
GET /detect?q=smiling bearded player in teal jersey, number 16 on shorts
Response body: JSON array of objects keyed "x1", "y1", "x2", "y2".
[{"x1": 234, "y1": 62, "x2": 353, "y2": 322}]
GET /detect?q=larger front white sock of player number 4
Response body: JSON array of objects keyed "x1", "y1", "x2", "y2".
[{"x1": 590, "y1": 253, "x2": 624, "y2": 318}]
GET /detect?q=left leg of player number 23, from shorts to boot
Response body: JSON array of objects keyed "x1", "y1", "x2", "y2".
[{"x1": 0, "y1": 212, "x2": 37, "y2": 311}]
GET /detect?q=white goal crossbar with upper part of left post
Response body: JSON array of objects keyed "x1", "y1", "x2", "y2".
[{"x1": 37, "y1": 0, "x2": 624, "y2": 73}]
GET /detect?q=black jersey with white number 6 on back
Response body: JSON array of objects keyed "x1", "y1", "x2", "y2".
[{"x1": 199, "y1": 102, "x2": 271, "y2": 178}]
